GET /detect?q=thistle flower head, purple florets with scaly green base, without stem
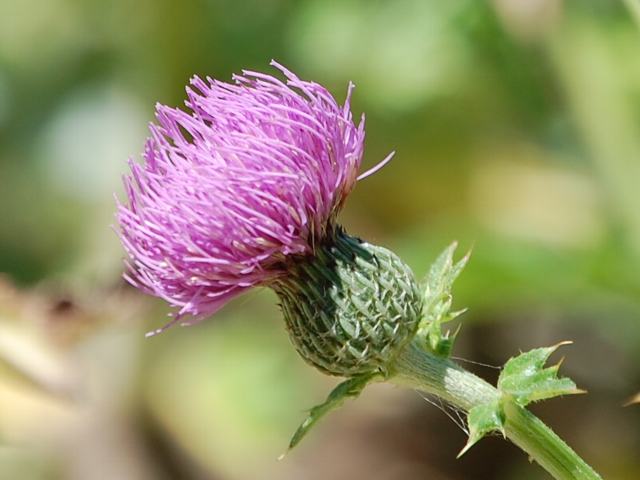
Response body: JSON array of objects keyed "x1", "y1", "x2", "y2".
[{"x1": 117, "y1": 62, "x2": 419, "y2": 374}]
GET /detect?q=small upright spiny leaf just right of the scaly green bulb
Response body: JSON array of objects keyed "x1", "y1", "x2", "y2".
[{"x1": 418, "y1": 242, "x2": 469, "y2": 357}]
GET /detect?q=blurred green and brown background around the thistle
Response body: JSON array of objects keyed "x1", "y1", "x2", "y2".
[{"x1": 0, "y1": 0, "x2": 640, "y2": 480}]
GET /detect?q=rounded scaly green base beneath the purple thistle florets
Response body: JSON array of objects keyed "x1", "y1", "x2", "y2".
[{"x1": 272, "y1": 229, "x2": 422, "y2": 376}]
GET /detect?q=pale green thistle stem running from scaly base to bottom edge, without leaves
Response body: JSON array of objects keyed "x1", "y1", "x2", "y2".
[{"x1": 390, "y1": 343, "x2": 602, "y2": 480}]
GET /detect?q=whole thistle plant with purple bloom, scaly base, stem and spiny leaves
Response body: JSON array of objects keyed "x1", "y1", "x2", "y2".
[{"x1": 117, "y1": 63, "x2": 601, "y2": 480}]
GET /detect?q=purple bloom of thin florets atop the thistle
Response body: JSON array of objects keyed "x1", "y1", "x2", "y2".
[{"x1": 117, "y1": 62, "x2": 390, "y2": 333}]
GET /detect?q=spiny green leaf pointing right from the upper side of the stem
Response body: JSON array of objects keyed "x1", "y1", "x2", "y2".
[{"x1": 498, "y1": 342, "x2": 584, "y2": 406}]
